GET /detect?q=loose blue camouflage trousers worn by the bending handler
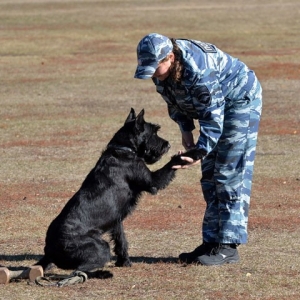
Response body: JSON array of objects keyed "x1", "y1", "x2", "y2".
[{"x1": 201, "y1": 74, "x2": 262, "y2": 244}]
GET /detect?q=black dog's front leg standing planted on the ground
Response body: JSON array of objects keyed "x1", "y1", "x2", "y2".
[{"x1": 111, "y1": 221, "x2": 131, "y2": 267}]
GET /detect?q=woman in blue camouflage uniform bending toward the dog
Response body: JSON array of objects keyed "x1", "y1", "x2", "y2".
[{"x1": 134, "y1": 33, "x2": 262, "y2": 265}]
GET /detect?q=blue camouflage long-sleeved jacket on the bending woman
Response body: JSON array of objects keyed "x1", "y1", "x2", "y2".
[{"x1": 152, "y1": 39, "x2": 255, "y2": 153}]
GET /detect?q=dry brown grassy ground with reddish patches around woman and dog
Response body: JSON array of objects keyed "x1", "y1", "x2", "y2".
[{"x1": 0, "y1": 0, "x2": 300, "y2": 300}]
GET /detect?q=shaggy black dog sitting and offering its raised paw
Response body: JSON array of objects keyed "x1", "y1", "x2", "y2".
[{"x1": 37, "y1": 109, "x2": 202, "y2": 272}]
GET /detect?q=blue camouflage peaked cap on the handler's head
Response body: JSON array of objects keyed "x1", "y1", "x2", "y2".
[{"x1": 134, "y1": 33, "x2": 173, "y2": 79}]
